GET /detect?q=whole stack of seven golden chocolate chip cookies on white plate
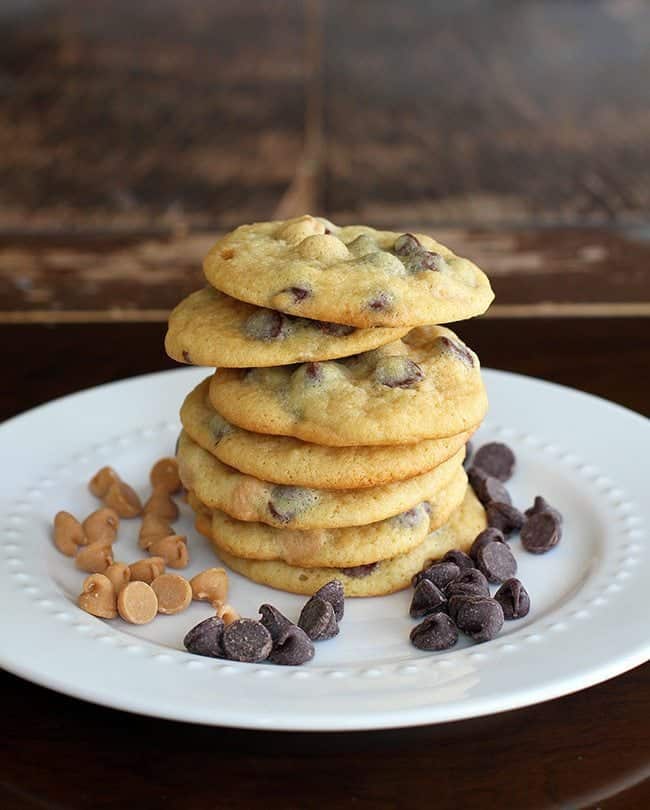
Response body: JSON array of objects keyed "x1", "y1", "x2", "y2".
[{"x1": 165, "y1": 216, "x2": 493, "y2": 596}]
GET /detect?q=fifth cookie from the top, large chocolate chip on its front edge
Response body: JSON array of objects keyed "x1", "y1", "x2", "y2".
[{"x1": 177, "y1": 433, "x2": 465, "y2": 529}]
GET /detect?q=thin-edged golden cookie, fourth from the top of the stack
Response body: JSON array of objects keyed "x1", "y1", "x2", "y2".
[{"x1": 181, "y1": 379, "x2": 473, "y2": 489}]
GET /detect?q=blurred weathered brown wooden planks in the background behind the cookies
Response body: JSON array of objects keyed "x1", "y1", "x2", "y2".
[{"x1": 0, "y1": 0, "x2": 650, "y2": 323}]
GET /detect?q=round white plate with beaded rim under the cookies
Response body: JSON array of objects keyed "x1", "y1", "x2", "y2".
[{"x1": 0, "y1": 369, "x2": 650, "y2": 730}]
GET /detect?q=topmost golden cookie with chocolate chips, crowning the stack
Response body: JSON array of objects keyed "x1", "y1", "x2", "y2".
[{"x1": 203, "y1": 216, "x2": 494, "y2": 327}]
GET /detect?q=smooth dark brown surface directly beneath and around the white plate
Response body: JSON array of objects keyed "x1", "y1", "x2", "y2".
[{"x1": 0, "y1": 318, "x2": 650, "y2": 810}]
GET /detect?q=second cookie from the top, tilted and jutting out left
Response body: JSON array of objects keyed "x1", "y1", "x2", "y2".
[{"x1": 165, "y1": 287, "x2": 408, "y2": 368}]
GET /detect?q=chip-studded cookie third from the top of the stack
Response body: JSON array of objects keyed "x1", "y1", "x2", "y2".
[{"x1": 210, "y1": 326, "x2": 487, "y2": 447}]
